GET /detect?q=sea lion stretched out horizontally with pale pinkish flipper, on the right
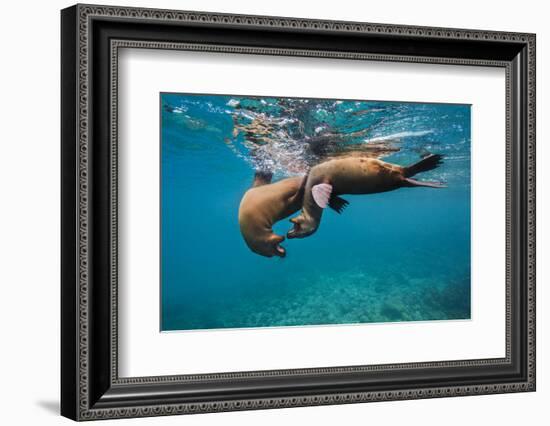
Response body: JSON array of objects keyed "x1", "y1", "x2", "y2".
[{"x1": 287, "y1": 154, "x2": 445, "y2": 238}]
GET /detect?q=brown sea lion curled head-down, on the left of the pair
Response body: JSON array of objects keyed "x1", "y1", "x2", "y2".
[{"x1": 239, "y1": 172, "x2": 305, "y2": 257}]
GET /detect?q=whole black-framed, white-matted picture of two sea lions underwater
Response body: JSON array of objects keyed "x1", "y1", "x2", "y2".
[{"x1": 61, "y1": 5, "x2": 535, "y2": 420}]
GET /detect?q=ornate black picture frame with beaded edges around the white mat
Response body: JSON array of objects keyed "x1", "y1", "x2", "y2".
[{"x1": 61, "y1": 5, "x2": 535, "y2": 420}]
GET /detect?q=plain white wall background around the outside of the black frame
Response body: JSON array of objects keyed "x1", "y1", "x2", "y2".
[{"x1": 0, "y1": 0, "x2": 550, "y2": 426}]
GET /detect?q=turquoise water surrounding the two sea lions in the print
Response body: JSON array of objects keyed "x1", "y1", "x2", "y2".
[{"x1": 160, "y1": 93, "x2": 470, "y2": 330}]
